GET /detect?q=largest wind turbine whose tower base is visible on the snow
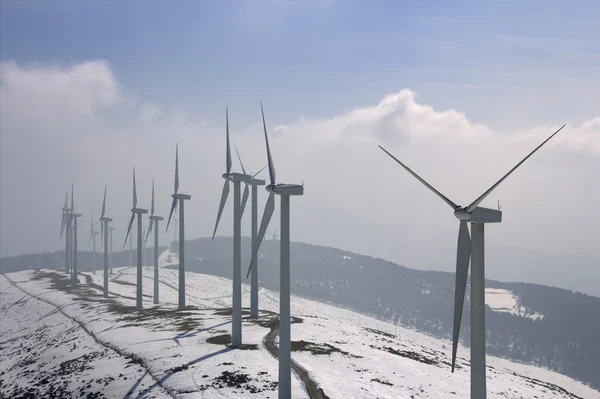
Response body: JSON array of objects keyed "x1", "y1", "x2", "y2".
[{"x1": 213, "y1": 108, "x2": 251, "y2": 348}]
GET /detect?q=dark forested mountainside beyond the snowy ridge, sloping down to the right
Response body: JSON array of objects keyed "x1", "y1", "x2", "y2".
[{"x1": 186, "y1": 237, "x2": 600, "y2": 389}]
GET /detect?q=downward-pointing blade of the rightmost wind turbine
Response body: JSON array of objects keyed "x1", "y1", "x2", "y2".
[{"x1": 452, "y1": 221, "x2": 471, "y2": 373}]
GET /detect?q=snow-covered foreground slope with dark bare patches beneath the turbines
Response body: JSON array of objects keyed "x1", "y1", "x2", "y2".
[{"x1": 0, "y1": 268, "x2": 600, "y2": 399}]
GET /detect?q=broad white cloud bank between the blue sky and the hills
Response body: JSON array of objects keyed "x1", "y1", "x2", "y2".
[{"x1": 0, "y1": 61, "x2": 600, "y2": 296}]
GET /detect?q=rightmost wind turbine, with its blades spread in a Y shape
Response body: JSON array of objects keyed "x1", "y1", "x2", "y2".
[{"x1": 379, "y1": 125, "x2": 565, "y2": 399}]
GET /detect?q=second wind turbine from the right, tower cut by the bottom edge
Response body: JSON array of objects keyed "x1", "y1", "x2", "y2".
[{"x1": 246, "y1": 103, "x2": 304, "y2": 398}]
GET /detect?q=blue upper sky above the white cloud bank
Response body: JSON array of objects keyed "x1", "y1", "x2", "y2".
[{"x1": 0, "y1": 0, "x2": 600, "y2": 129}]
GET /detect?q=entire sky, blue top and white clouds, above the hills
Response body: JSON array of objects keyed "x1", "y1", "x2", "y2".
[{"x1": 0, "y1": 0, "x2": 600, "y2": 296}]
